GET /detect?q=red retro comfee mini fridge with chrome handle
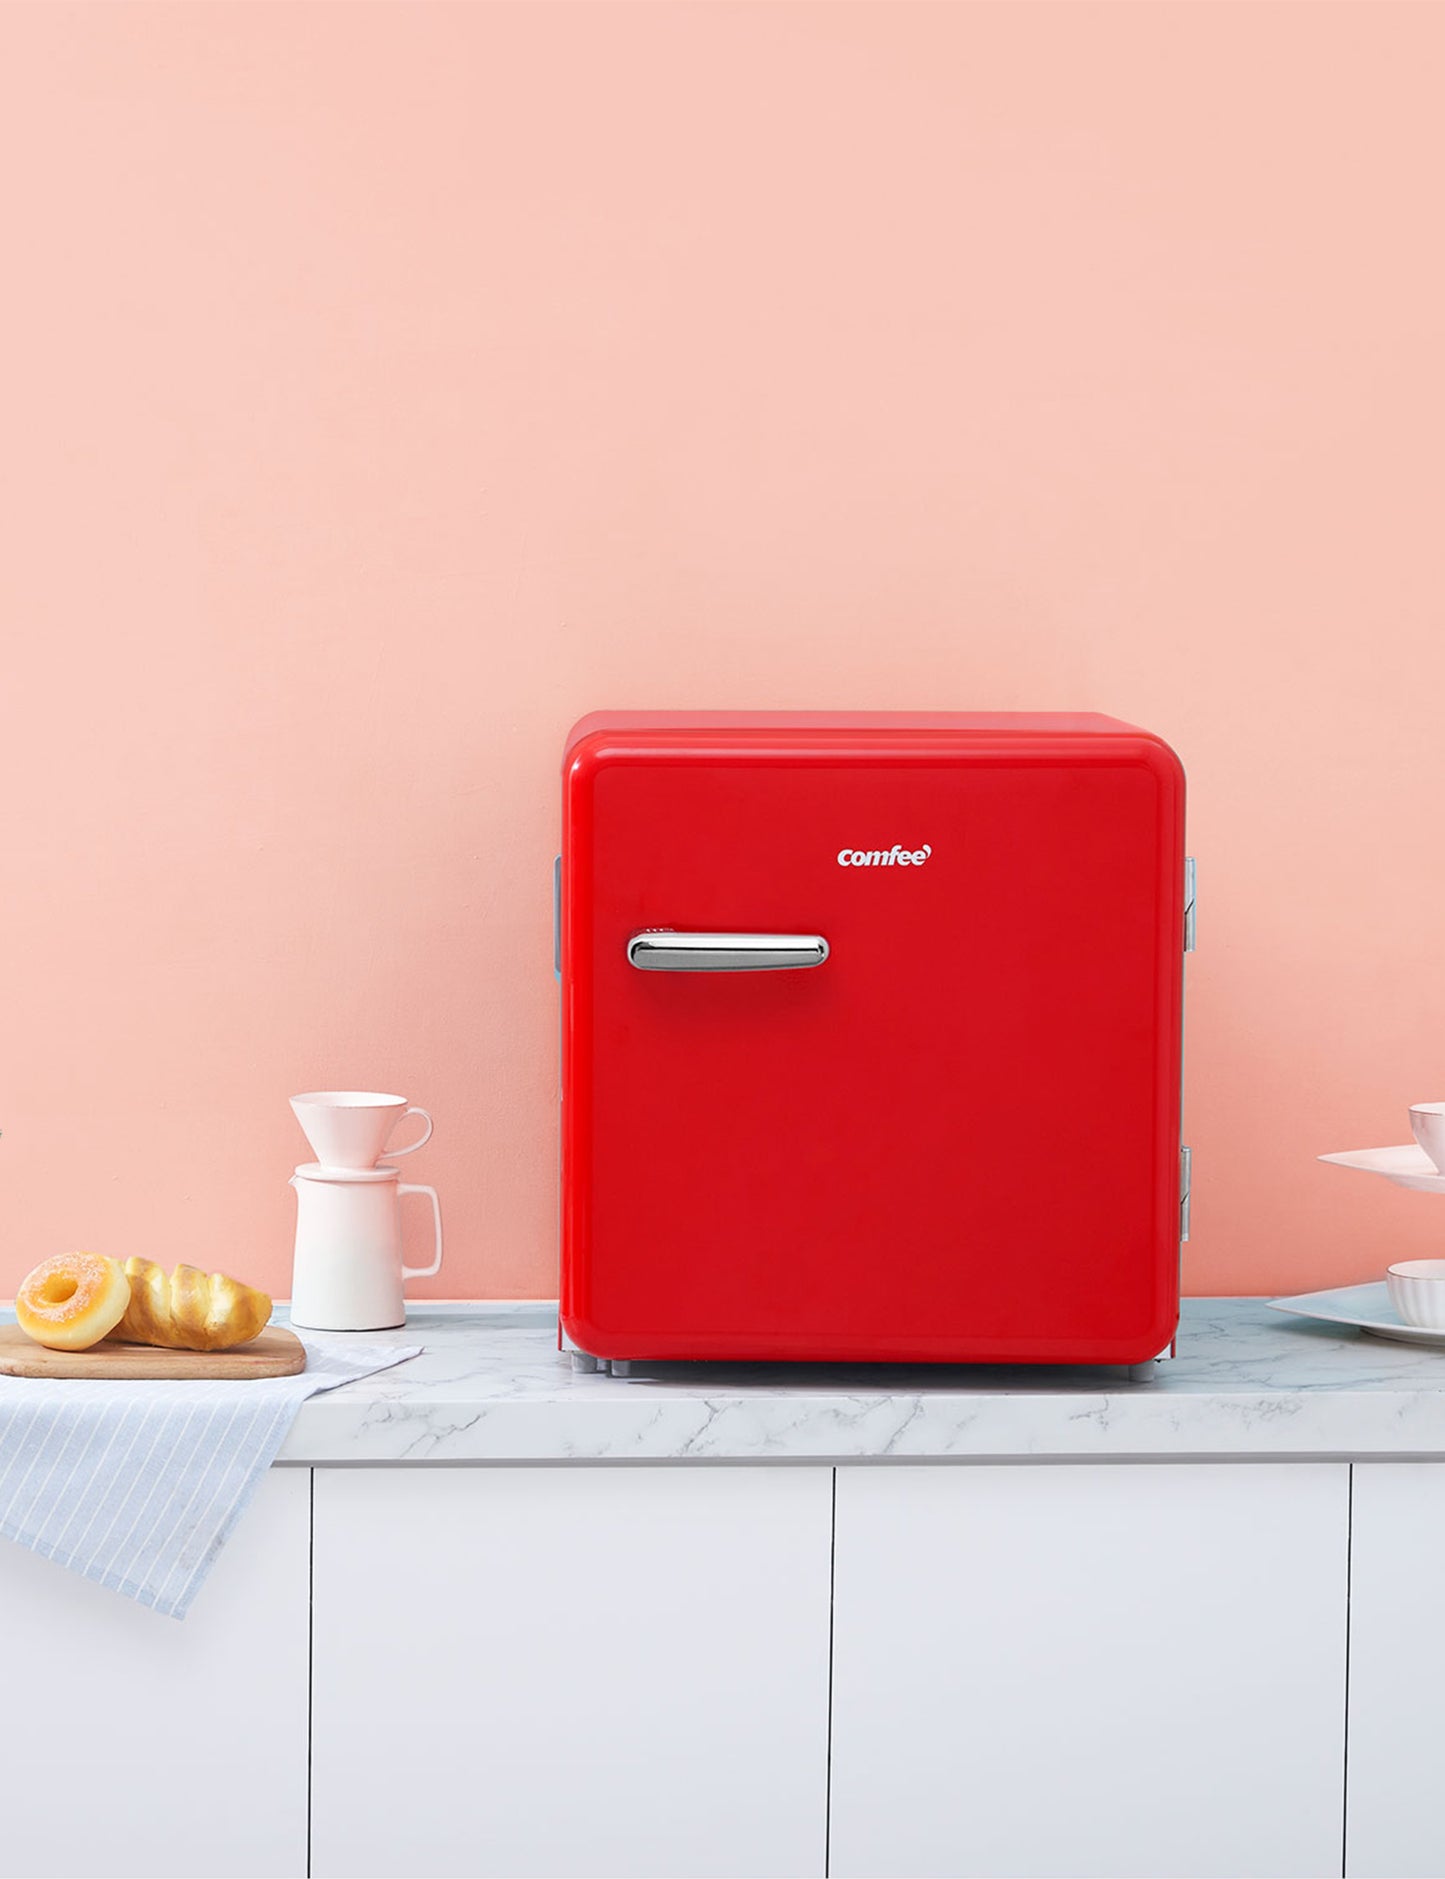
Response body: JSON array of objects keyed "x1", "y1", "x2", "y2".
[{"x1": 558, "y1": 712, "x2": 1193, "y2": 1364}]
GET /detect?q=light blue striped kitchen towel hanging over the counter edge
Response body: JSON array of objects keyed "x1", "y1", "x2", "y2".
[{"x1": 0, "y1": 1313, "x2": 421, "y2": 1618}]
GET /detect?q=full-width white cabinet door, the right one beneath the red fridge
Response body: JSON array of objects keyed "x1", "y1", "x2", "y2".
[{"x1": 831, "y1": 1464, "x2": 1349, "y2": 1879}]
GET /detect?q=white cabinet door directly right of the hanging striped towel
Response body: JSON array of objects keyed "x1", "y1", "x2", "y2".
[{"x1": 312, "y1": 1466, "x2": 832, "y2": 1879}]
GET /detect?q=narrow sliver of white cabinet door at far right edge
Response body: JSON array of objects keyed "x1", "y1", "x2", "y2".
[{"x1": 1345, "y1": 1462, "x2": 1445, "y2": 1879}]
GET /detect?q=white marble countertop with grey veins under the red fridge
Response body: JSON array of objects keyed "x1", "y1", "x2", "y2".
[{"x1": 280, "y1": 1298, "x2": 1445, "y2": 1464}]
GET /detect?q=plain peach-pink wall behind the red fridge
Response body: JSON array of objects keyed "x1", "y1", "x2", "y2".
[{"x1": 0, "y1": 0, "x2": 1445, "y2": 1295}]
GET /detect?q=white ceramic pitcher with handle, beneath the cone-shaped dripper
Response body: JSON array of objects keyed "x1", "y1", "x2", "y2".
[{"x1": 291, "y1": 1161, "x2": 442, "y2": 1330}]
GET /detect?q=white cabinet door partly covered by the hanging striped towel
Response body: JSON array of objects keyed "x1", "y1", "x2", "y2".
[{"x1": 0, "y1": 1467, "x2": 310, "y2": 1879}]
